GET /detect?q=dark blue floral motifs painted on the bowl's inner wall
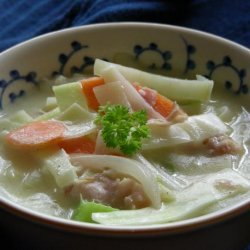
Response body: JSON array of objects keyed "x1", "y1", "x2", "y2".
[{"x1": 0, "y1": 36, "x2": 249, "y2": 108}]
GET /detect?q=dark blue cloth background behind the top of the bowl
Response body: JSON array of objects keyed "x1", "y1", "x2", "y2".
[{"x1": 0, "y1": 0, "x2": 250, "y2": 51}]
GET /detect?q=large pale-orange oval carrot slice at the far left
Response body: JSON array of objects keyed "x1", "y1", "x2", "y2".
[{"x1": 6, "y1": 121, "x2": 66, "y2": 149}]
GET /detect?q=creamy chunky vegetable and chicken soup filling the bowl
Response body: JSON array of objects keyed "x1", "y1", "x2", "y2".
[{"x1": 0, "y1": 59, "x2": 250, "y2": 226}]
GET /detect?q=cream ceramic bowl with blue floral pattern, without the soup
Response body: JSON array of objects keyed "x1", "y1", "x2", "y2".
[{"x1": 0, "y1": 23, "x2": 250, "y2": 249}]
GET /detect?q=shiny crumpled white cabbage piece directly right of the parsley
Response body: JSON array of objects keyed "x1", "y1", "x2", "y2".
[{"x1": 142, "y1": 113, "x2": 230, "y2": 149}]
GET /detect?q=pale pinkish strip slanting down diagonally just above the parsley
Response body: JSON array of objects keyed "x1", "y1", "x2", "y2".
[{"x1": 97, "y1": 67, "x2": 165, "y2": 120}]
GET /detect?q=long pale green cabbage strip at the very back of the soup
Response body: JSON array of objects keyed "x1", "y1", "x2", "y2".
[{"x1": 94, "y1": 59, "x2": 214, "y2": 102}]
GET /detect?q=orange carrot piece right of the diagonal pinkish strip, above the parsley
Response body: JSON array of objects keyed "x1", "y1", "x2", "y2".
[{"x1": 134, "y1": 83, "x2": 174, "y2": 117}]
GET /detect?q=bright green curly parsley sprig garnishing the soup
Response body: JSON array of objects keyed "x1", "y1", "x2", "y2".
[{"x1": 95, "y1": 104, "x2": 149, "y2": 156}]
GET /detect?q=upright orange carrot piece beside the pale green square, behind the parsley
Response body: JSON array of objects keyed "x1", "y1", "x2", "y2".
[{"x1": 81, "y1": 77, "x2": 105, "y2": 111}]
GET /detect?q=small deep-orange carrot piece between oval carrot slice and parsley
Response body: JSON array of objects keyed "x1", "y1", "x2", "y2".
[{"x1": 58, "y1": 136, "x2": 95, "y2": 154}]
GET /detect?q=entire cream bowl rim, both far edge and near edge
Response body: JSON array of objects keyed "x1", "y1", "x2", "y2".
[{"x1": 0, "y1": 22, "x2": 250, "y2": 237}]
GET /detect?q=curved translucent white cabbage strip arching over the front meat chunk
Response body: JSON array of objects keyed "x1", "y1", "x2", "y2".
[{"x1": 71, "y1": 155, "x2": 161, "y2": 208}]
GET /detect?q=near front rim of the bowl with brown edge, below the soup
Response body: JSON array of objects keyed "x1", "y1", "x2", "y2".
[{"x1": 0, "y1": 192, "x2": 250, "y2": 237}]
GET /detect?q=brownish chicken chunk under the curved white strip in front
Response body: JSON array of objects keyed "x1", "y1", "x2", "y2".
[{"x1": 69, "y1": 169, "x2": 150, "y2": 209}]
